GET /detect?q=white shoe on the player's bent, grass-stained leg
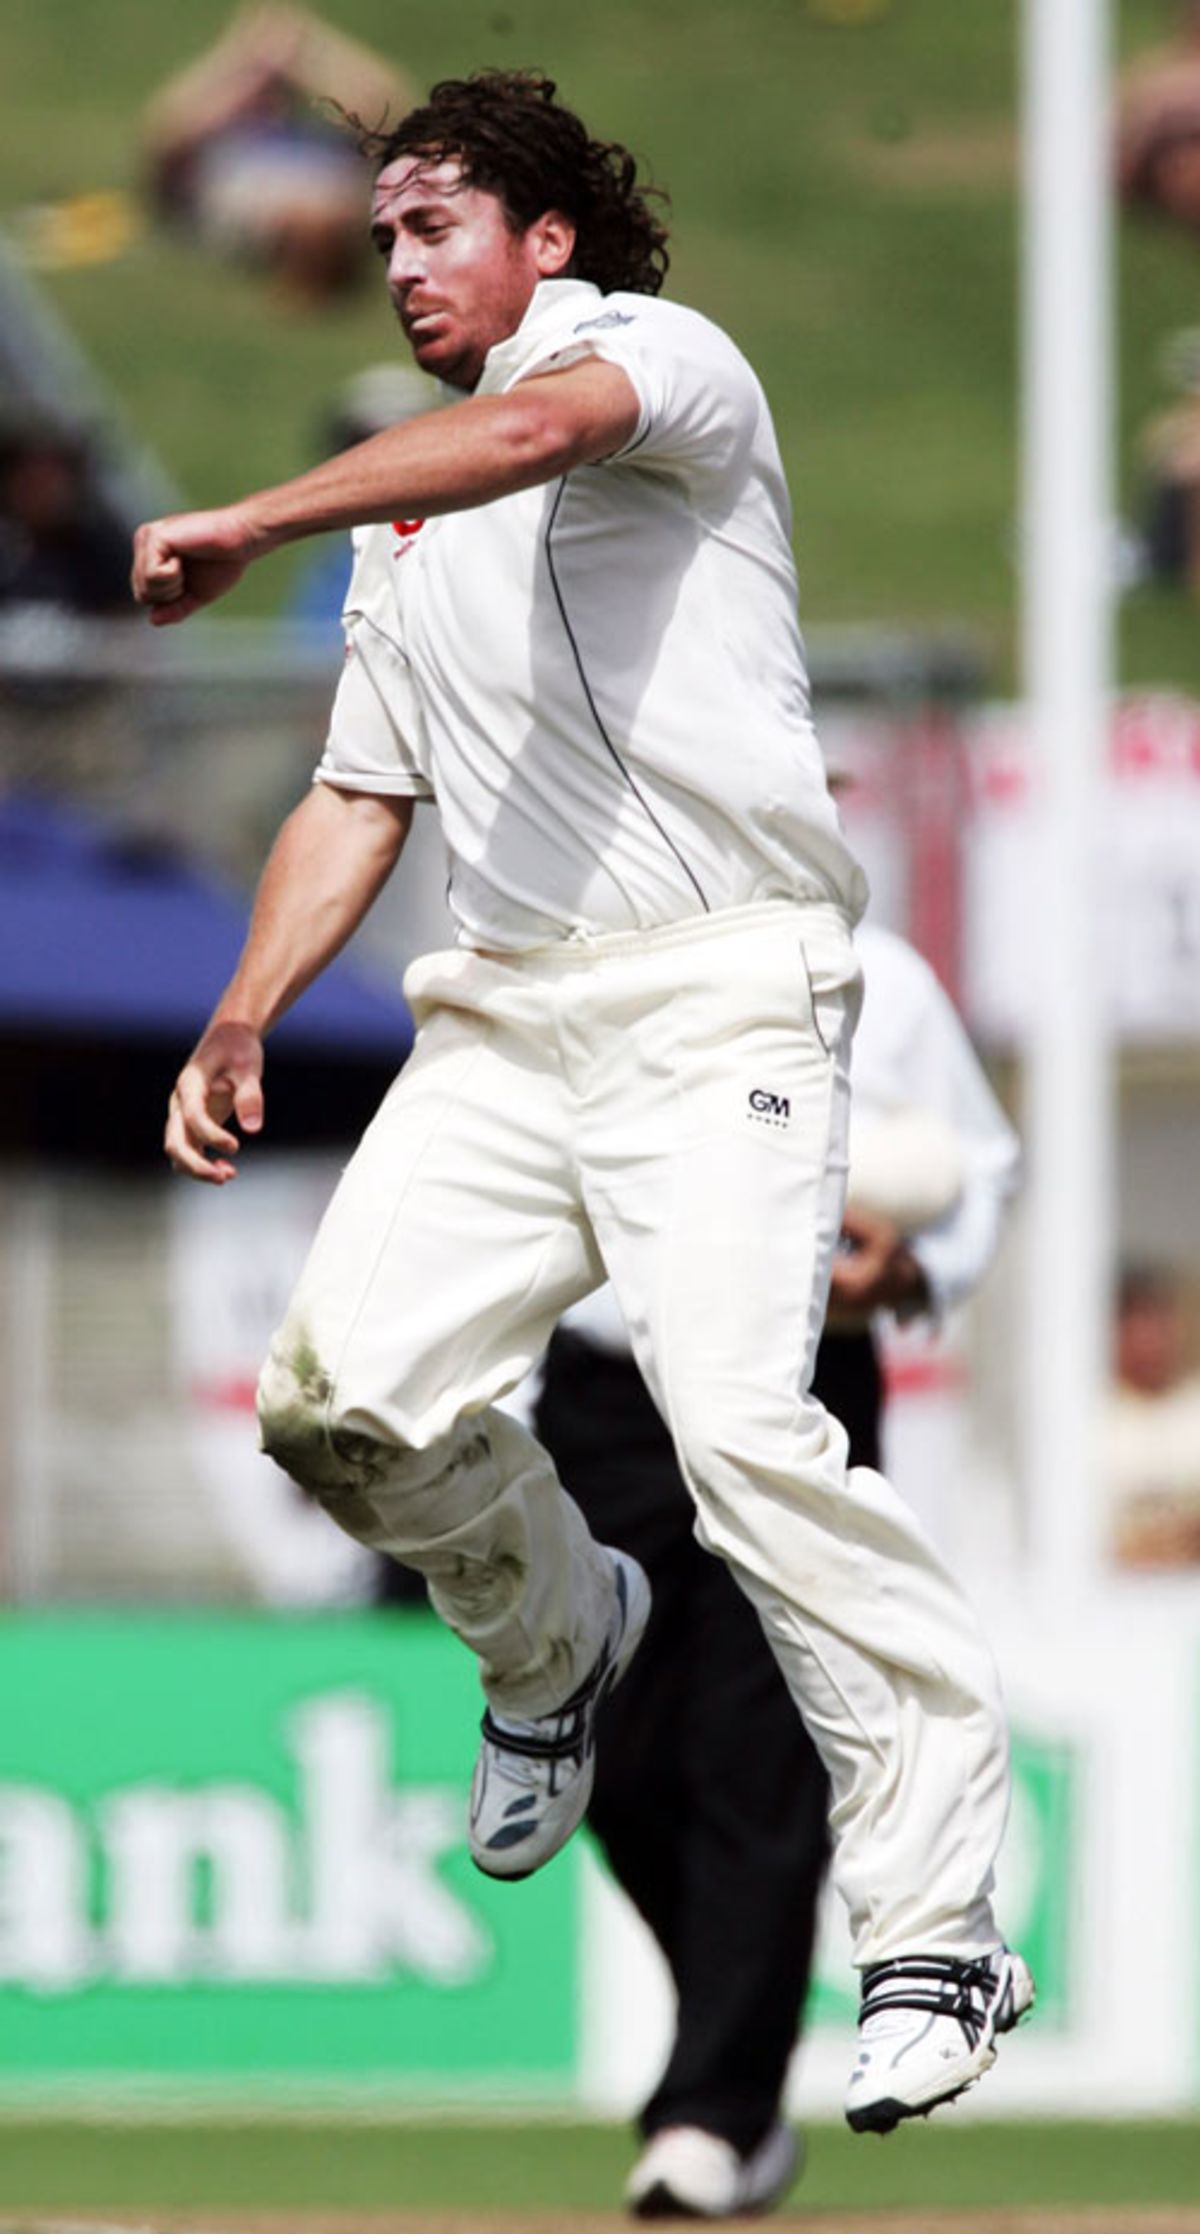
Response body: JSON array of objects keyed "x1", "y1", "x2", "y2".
[{"x1": 467, "y1": 1546, "x2": 650, "y2": 1877}]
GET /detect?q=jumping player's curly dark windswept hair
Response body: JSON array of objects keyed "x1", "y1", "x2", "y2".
[{"x1": 358, "y1": 69, "x2": 668, "y2": 295}]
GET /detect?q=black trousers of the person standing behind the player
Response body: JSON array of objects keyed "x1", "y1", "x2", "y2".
[{"x1": 534, "y1": 1331, "x2": 880, "y2": 2156}]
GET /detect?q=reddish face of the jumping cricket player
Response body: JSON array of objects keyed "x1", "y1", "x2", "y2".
[{"x1": 371, "y1": 154, "x2": 574, "y2": 389}]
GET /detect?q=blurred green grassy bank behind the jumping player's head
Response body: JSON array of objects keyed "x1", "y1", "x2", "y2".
[{"x1": 0, "y1": 0, "x2": 1200, "y2": 688}]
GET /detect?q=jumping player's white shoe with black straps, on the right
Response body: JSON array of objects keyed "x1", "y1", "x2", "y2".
[{"x1": 847, "y1": 1946, "x2": 1035, "y2": 2133}]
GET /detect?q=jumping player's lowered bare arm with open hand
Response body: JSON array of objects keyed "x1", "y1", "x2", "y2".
[{"x1": 163, "y1": 784, "x2": 413, "y2": 1186}]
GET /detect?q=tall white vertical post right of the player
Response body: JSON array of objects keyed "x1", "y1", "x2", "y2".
[{"x1": 1023, "y1": 0, "x2": 1113, "y2": 1588}]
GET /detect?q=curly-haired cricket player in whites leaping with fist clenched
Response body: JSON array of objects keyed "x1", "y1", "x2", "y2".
[{"x1": 134, "y1": 71, "x2": 1032, "y2": 2131}]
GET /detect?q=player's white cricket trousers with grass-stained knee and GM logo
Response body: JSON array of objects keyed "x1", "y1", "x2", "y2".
[{"x1": 259, "y1": 903, "x2": 1008, "y2": 1964}]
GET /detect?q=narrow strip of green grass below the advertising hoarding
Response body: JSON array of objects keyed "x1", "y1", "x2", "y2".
[{"x1": 0, "y1": 2118, "x2": 1200, "y2": 2214}]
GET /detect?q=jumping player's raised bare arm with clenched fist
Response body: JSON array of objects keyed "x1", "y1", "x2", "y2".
[{"x1": 132, "y1": 357, "x2": 639, "y2": 626}]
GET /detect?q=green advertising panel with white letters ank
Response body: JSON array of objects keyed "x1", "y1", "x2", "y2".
[{"x1": 0, "y1": 1613, "x2": 579, "y2": 2100}]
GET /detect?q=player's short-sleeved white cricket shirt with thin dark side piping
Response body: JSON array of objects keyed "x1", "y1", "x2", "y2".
[{"x1": 317, "y1": 279, "x2": 865, "y2": 949}]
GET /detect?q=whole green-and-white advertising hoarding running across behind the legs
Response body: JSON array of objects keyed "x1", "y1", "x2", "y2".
[{"x1": 0, "y1": 1593, "x2": 1200, "y2": 2118}]
